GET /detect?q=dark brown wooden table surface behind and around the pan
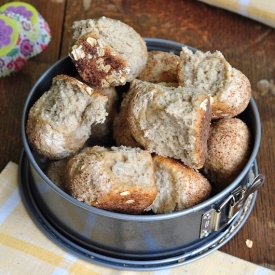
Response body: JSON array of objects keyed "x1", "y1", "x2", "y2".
[{"x1": 0, "y1": 0, "x2": 275, "y2": 270}]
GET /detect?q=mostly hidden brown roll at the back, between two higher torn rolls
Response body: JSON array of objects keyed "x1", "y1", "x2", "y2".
[{"x1": 138, "y1": 51, "x2": 180, "y2": 83}]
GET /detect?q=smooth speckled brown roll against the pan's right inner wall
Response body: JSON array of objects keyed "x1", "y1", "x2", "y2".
[{"x1": 202, "y1": 118, "x2": 251, "y2": 192}]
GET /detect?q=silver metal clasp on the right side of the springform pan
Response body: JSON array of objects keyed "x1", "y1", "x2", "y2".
[{"x1": 200, "y1": 174, "x2": 265, "y2": 238}]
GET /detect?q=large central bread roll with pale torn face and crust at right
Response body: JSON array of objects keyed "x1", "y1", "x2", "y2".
[{"x1": 125, "y1": 80, "x2": 211, "y2": 169}]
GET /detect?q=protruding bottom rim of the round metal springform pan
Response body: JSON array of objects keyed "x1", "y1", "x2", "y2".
[{"x1": 19, "y1": 151, "x2": 258, "y2": 271}]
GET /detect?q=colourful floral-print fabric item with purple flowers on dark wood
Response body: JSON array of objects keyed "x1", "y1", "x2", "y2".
[{"x1": 0, "y1": 2, "x2": 51, "y2": 77}]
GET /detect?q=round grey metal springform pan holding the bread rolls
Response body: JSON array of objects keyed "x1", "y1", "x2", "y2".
[{"x1": 20, "y1": 38, "x2": 264, "y2": 269}]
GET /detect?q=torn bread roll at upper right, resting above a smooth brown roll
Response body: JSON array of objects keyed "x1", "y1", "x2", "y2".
[{"x1": 178, "y1": 47, "x2": 251, "y2": 119}]
